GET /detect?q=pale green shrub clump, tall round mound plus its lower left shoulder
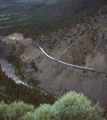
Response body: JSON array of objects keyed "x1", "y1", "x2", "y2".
[{"x1": 23, "y1": 92, "x2": 105, "y2": 120}]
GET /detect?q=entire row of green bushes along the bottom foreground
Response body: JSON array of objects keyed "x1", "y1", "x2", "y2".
[{"x1": 0, "y1": 86, "x2": 106, "y2": 120}]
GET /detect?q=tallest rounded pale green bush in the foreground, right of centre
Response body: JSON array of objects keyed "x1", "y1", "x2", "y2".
[{"x1": 53, "y1": 92, "x2": 103, "y2": 120}]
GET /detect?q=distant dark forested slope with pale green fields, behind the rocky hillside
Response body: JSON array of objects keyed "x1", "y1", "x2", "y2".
[{"x1": 0, "y1": 0, "x2": 106, "y2": 38}]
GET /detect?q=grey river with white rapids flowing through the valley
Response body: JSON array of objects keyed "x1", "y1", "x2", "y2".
[{"x1": 0, "y1": 58, "x2": 27, "y2": 85}]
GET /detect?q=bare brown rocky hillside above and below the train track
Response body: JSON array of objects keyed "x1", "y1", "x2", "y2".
[{"x1": 2, "y1": 6, "x2": 107, "y2": 108}]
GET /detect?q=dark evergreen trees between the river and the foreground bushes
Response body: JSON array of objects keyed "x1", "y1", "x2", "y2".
[{"x1": 0, "y1": 65, "x2": 56, "y2": 107}]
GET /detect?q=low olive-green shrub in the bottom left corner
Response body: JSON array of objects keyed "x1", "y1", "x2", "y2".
[{"x1": 0, "y1": 101, "x2": 34, "y2": 120}]
